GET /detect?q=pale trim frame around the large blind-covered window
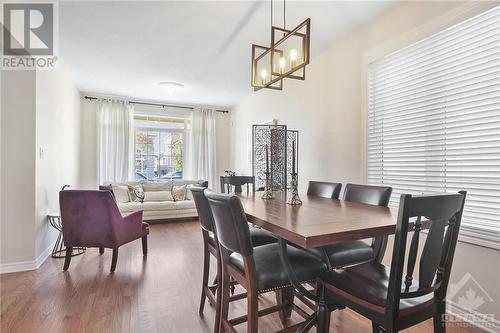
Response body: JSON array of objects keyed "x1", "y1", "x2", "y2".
[{"x1": 360, "y1": 2, "x2": 500, "y2": 246}]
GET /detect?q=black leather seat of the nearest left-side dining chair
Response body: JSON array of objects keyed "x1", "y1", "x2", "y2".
[{"x1": 229, "y1": 243, "x2": 327, "y2": 292}]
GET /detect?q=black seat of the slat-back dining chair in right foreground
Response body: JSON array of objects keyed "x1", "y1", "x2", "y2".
[{"x1": 318, "y1": 261, "x2": 434, "y2": 315}]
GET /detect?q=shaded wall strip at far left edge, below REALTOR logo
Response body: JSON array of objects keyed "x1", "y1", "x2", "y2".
[{"x1": 0, "y1": 71, "x2": 36, "y2": 271}]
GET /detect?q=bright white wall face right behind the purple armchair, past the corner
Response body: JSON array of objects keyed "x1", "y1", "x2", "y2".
[{"x1": 35, "y1": 70, "x2": 80, "y2": 258}]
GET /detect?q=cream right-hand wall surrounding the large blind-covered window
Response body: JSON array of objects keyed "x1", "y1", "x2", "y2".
[{"x1": 231, "y1": 1, "x2": 500, "y2": 330}]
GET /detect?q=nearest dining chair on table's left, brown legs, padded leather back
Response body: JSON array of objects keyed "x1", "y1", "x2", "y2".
[{"x1": 205, "y1": 190, "x2": 327, "y2": 333}]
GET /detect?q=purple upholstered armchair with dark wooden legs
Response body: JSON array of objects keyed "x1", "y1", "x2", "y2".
[{"x1": 59, "y1": 190, "x2": 149, "y2": 272}]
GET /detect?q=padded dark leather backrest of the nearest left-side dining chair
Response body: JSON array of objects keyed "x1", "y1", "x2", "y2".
[{"x1": 205, "y1": 190, "x2": 253, "y2": 257}]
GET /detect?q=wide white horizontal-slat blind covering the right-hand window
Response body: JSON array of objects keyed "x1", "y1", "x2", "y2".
[{"x1": 367, "y1": 7, "x2": 500, "y2": 241}]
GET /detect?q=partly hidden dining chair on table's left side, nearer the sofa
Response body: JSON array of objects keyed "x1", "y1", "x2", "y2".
[{"x1": 188, "y1": 185, "x2": 277, "y2": 333}]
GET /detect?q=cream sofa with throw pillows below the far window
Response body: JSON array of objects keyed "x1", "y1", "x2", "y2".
[{"x1": 99, "y1": 179, "x2": 208, "y2": 221}]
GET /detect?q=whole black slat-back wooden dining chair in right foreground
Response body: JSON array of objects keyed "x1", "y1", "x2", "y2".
[{"x1": 318, "y1": 191, "x2": 466, "y2": 333}]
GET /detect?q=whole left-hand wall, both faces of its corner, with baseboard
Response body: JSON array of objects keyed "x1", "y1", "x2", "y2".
[{"x1": 0, "y1": 70, "x2": 80, "y2": 272}]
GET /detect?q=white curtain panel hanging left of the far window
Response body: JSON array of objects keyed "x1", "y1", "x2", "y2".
[{"x1": 96, "y1": 100, "x2": 133, "y2": 184}]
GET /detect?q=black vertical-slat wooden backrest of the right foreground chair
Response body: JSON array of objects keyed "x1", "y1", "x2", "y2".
[{"x1": 387, "y1": 191, "x2": 466, "y2": 315}]
